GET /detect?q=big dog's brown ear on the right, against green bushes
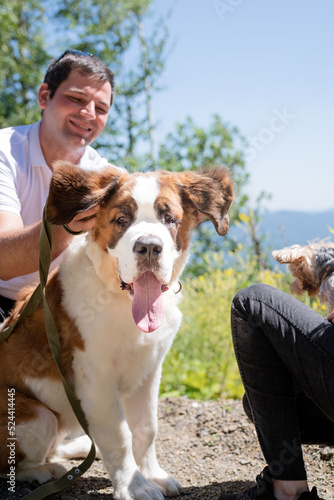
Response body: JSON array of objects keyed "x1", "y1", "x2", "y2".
[{"x1": 177, "y1": 166, "x2": 234, "y2": 236}]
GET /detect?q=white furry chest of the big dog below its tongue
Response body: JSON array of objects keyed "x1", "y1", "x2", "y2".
[{"x1": 61, "y1": 249, "x2": 182, "y2": 394}]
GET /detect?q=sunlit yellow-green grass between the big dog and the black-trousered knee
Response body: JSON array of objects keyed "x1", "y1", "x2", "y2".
[{"x1": 161, "y1": 253, "x2": 327, "y2": 399}]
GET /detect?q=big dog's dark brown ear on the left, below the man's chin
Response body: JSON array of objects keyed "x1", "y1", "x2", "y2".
[{"x1": 46, "y1": 161, "x2": 121, "y2": 225}]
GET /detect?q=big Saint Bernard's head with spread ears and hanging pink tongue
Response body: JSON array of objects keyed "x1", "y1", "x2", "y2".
[{"x1": 46, "y1": 162, "x2": 234, "y2": 331}]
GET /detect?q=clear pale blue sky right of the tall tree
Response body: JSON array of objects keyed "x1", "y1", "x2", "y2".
[{"x1": 147, "y1": 0, "x2": 334, "y2": 212}]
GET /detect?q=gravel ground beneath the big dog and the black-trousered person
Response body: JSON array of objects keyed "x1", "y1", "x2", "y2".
[{"x1": 0, "y1": 398, "x2": 334, "y2": 500}]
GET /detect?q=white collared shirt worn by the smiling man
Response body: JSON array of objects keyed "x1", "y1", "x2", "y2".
[{"x1": 0, "y1": 122, "x2": 108, "y2": 298}]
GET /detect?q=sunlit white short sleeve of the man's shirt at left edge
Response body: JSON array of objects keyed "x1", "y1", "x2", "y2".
[{"x1": 0, "y1": 152, "x2": 21, "y2": 215}]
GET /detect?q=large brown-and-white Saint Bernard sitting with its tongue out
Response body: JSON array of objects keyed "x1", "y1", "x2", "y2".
[{"x1": 0, "y1": 162, "x2": 234, "y2": 500}]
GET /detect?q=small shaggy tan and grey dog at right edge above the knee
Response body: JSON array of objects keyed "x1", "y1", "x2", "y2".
[{"x1": 272, "y1": 241, "x2": 334, "y2": 311}]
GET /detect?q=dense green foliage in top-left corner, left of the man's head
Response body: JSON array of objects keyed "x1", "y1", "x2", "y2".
[{"x1": 0, "y1": 0, "x2": 48, "y2": 128}]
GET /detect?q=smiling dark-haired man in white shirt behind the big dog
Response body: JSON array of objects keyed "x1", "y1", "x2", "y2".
[{"x1": 0, "y1": 50, "x2": 114, "y2": 321}]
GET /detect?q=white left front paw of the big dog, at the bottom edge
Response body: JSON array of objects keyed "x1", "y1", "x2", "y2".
[{"x1": 114, "y1": 471, "x2": 164, "y2": 500}]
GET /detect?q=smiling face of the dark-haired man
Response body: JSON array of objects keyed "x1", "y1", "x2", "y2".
[{"x1": 38, "y1": 70, "x2": 112, "y2": 149}]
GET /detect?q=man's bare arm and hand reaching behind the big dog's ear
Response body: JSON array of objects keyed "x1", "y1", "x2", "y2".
[{"x1": 0, "y1": 206, "x2": 99, "y2": 281}]
